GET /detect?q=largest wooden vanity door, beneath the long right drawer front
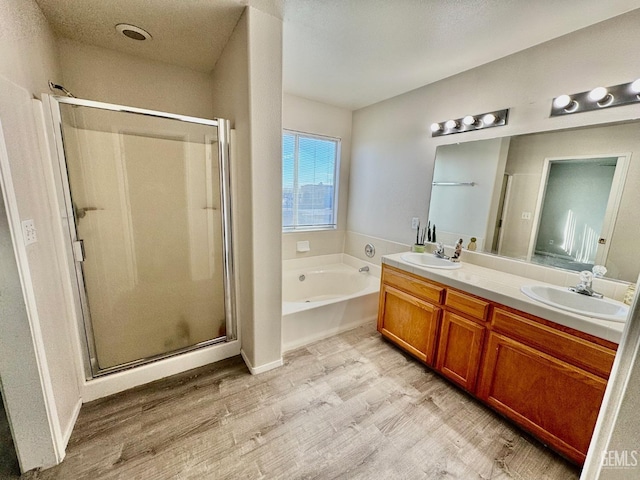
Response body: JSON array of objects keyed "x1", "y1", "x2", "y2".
[{"x1": 478, "y1": 332, "x2": 607, "y2": 464}]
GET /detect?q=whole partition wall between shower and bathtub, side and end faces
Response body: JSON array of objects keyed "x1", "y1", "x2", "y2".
[{"x1": 212, "y1": 7, "x2": 282, "y2": 373}]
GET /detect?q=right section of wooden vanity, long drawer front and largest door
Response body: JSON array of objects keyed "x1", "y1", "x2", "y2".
[{"x1": 477, "y1": 308, "x2": 615, "y2": 464}]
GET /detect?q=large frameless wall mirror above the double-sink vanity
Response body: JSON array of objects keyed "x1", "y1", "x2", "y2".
[{"x1": 429, "y1": 121, "x2": 640, "y2": 282}]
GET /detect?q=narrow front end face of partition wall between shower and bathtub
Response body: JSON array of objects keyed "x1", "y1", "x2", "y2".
[{"x1": 243, "y1": 7, "x2": 282, "y2": 373}]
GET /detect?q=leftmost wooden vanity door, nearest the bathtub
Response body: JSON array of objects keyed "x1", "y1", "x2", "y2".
[{"x1": 378, "y1": 284, "x2": 440, "y2": 366}]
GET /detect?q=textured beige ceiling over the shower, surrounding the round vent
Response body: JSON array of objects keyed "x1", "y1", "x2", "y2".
[{"x1": 36, "y1": 0, "x2": 248, "y2": 72}]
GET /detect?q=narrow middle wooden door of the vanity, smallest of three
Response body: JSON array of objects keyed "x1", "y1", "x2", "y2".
[{"x1": 436, "y1": 312, "x2": 485, "y2": 392}]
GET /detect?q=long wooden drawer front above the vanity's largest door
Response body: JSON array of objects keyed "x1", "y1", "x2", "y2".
[{"x1": 491, "y1": 308, "x2": 616, "y2": 379}]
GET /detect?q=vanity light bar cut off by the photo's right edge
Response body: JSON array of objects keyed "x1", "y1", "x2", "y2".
[{"x1": 550, "y1": 78, "x2": 640, "y2": 117}]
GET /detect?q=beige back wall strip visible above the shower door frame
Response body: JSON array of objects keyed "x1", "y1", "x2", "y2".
[{"x1": 58, "y1": 38, "x2": 213, "y2": 118}]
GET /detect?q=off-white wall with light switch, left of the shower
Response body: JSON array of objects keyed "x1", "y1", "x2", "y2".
[{"x1": 0, "y1": 0, "x2": 80, "y2": 469}]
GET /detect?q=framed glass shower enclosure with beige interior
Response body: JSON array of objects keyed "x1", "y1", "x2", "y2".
[{"x1": 48, "y1": 97, "x2": 236, "y2": 378}]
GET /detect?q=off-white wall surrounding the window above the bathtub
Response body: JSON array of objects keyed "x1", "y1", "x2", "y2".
[{"x1": 282, "y1": 94, "x2": 352, "y2": 260}]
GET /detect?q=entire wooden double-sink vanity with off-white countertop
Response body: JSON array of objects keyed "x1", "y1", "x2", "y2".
[{"x1": 378, "y1": 255, "x2": 624, "y2": 465}]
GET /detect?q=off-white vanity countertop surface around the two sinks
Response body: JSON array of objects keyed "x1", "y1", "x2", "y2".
[{"x1": 382, "y1": 253, "x2": 626, "y2": 343}]
